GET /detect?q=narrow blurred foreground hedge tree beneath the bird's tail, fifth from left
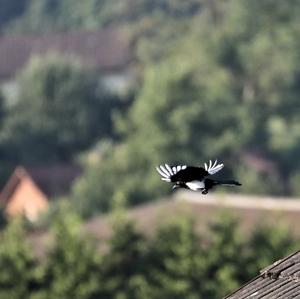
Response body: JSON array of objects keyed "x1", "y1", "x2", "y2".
[{"x1": 202, "y1": 212, "x2": 247, "y2": 298}]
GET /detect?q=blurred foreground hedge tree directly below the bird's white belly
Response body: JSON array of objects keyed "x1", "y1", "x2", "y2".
[{"x1": 146, "y1": 216, "x2": 207, "y2": 299}]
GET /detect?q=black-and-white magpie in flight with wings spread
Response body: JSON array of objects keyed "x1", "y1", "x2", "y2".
[{"x1": 156, "y1": 160, "x2": 241, "y2": 194}]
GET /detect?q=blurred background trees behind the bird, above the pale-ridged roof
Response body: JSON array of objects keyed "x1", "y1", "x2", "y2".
[{"x1": 0, "y1": 0, "x2": 300, "y2": 216}]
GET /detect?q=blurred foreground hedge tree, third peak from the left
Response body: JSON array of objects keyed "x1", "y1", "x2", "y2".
[{"x1": 101, "y1": 219, "x2": 148, "y2": 299}]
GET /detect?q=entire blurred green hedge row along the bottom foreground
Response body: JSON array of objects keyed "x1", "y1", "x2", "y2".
[{"x1": 0, "y1": 209, "x2": 299, "y2": 299}]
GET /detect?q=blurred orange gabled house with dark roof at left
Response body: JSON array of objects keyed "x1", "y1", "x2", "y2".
[{"x1": 0, "y1": 165, "x2": 80, "y2": 221}]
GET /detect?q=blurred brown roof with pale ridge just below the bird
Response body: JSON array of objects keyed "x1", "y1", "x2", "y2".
[{"x1": 86, "y1": 191, "x2": 300, "y2": 244}]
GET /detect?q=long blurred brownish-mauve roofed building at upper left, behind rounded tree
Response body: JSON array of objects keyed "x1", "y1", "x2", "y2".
[{"x1": 0, "y1": 29, "x2": 133, "y2": 98}]
